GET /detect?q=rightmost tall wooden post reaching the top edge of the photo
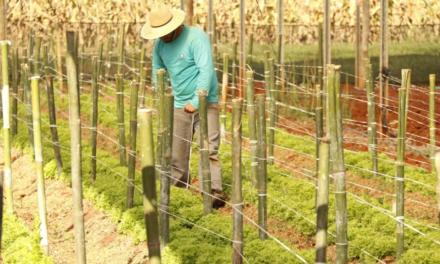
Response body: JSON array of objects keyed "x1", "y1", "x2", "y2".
[{"x1": 379, "y1": 0, "x2": 389, "y2": 135}]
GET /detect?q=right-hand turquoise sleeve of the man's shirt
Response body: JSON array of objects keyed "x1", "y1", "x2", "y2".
[{"x1": 190, "y1": 34, "x2": 214, "y2": 109}]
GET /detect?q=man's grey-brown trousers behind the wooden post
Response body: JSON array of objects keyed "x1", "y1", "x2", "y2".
[{"x1": 171, "y1": 104, "x2": 223, "y2": 191}]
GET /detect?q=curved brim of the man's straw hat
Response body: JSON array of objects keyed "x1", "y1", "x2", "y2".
[{"x1": 141, "y1": 9, "x2": 185, "y2": 40}]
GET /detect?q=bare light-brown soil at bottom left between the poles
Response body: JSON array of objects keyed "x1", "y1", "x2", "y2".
[{"x1": 2, "y1": 147, "x2": 148, "y2": 264}]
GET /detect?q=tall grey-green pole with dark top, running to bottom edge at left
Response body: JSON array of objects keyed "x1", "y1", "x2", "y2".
[{"x1": 66, "y1": 31, "x2": 86, "y2": 264}]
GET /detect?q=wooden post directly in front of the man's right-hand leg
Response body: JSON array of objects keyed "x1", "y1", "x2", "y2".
[{"x1": 199, "y1": 90, "x2": 212, "y2": 214}]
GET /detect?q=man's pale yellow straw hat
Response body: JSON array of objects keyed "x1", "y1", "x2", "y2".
[{"x1": 141, "y1": 7, "x2": 185, "y2": 39}]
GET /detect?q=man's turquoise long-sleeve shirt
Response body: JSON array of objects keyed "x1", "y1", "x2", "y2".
[{"x1": 152, "y1": 26, "x2": 218, "y2": 109}]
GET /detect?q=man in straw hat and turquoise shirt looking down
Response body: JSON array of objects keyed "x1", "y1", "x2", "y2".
[{"x1": 141, "y1": 7, "x2": 225, "y2": 208}]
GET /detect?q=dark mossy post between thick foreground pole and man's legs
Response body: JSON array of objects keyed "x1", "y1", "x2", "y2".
[{"x1": 159, "y1": 90, "x2": 174, "y2": 247}]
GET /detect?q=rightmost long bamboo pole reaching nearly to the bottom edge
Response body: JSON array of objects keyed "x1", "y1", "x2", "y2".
[{"x1": 396, "y1": 69, "x2": 411, "y2": 260}]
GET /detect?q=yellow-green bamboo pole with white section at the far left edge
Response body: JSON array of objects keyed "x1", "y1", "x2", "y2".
[{"x1": 0, "y1": 40, "x2": 14, "y2": 214}]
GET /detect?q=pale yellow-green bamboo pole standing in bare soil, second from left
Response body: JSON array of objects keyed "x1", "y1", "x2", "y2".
[{"x1": 31, "y1": 76, "x2": 49, "y2": 255}]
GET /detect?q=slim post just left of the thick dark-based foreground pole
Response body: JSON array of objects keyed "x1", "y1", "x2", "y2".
[{"x1": 126, "y1": 77, "x2": 139, "y2": 208}]
